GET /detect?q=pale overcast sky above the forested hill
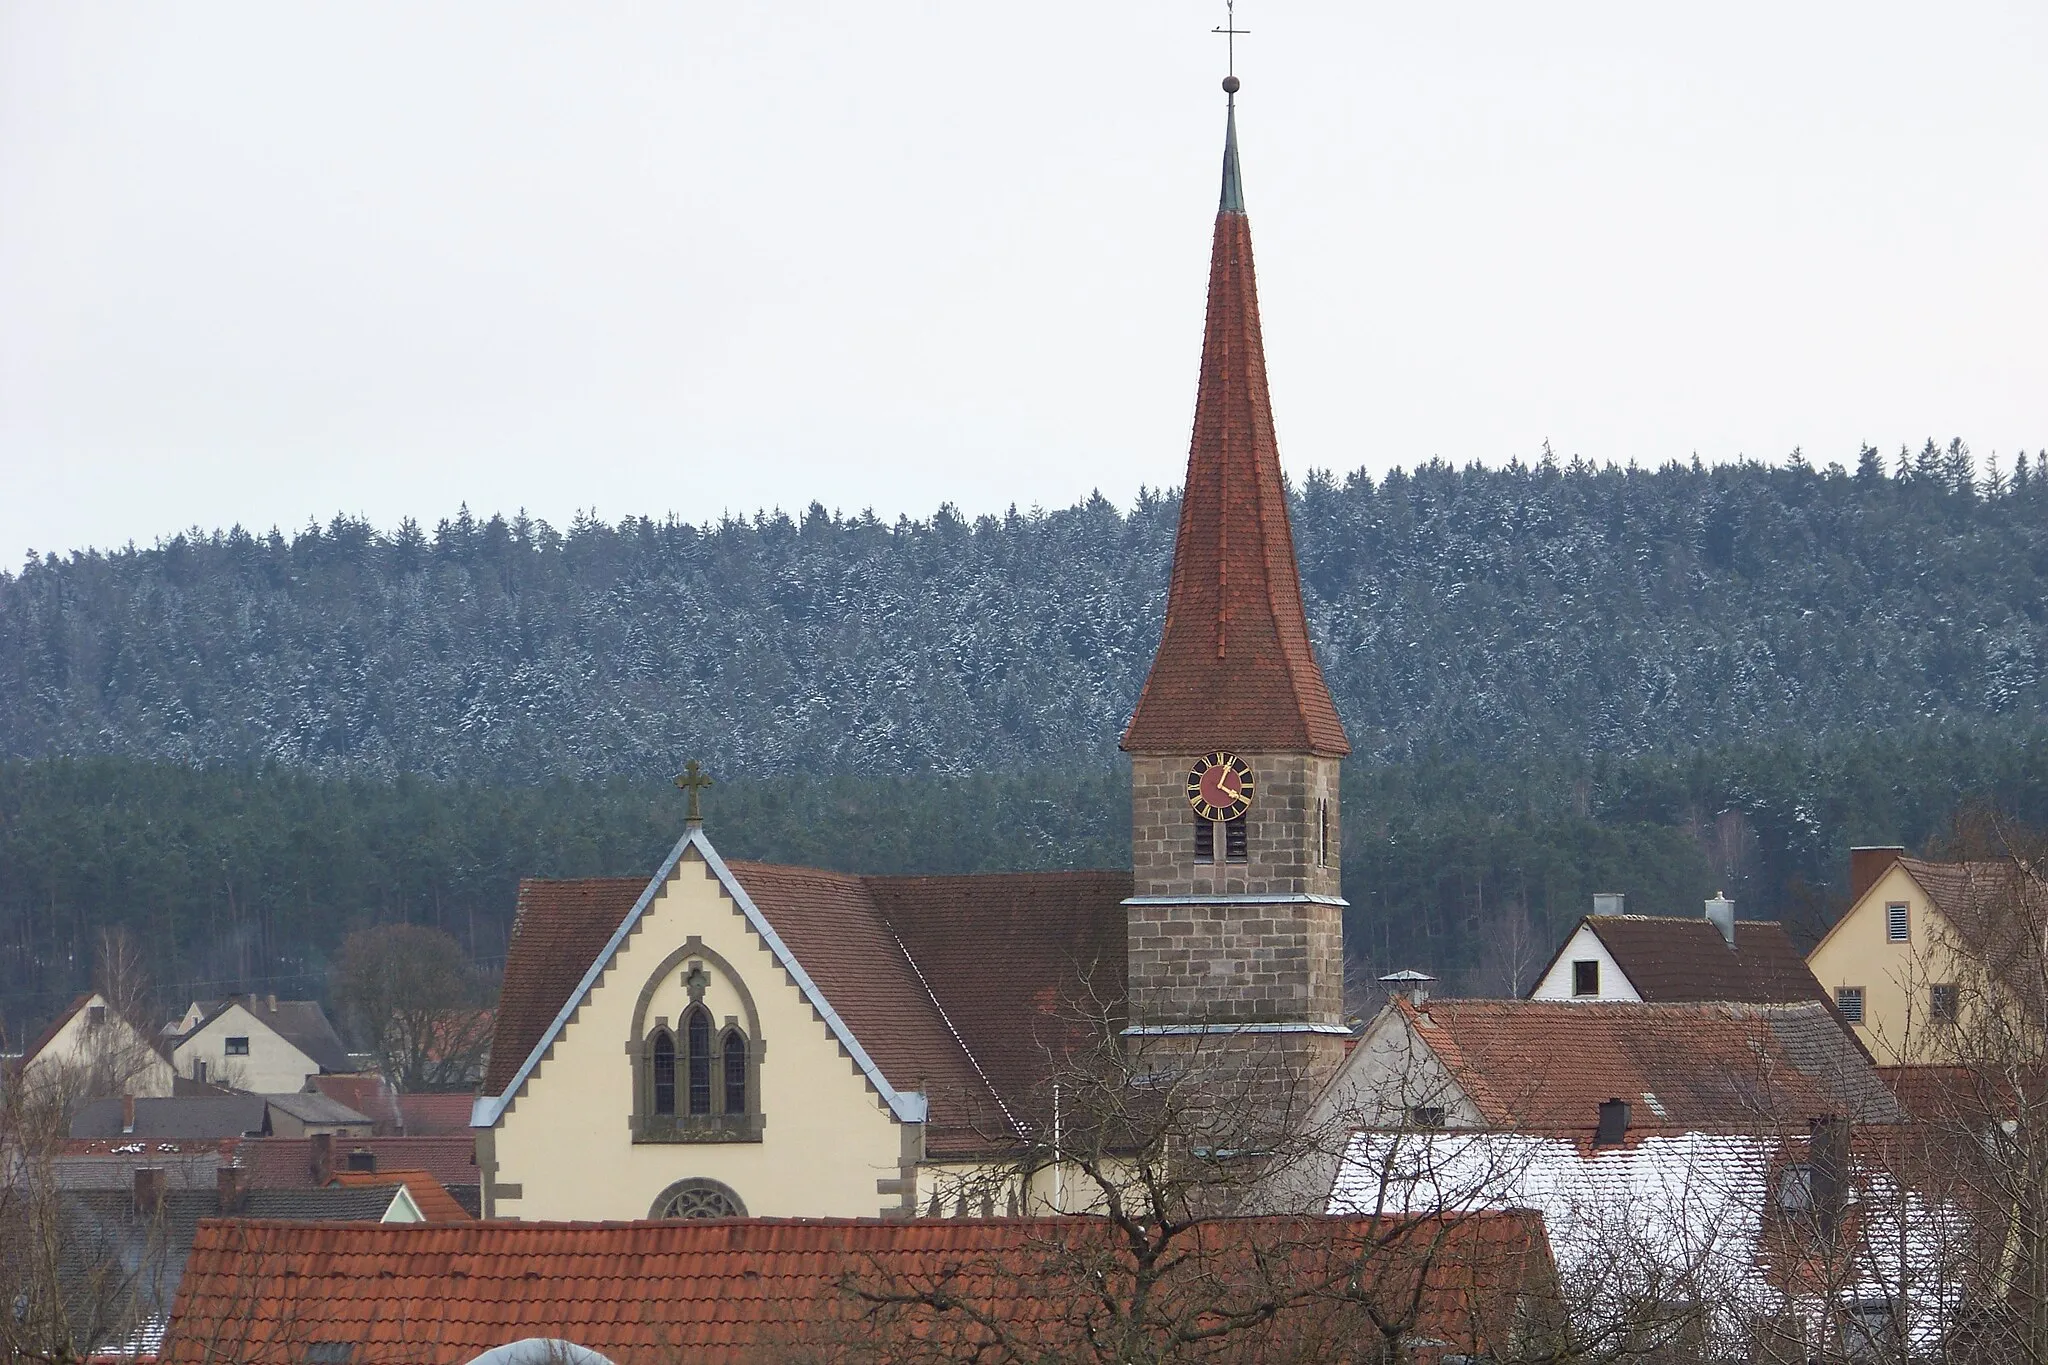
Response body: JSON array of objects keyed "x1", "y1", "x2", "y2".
[{"x1": 0, "y1": 0, "x2": 2048, "y2": 567}]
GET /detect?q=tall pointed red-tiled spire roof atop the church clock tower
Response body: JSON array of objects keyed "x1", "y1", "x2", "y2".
[{"x1": 1122, "y1": 96, "x2": 1352, "y2": 757}]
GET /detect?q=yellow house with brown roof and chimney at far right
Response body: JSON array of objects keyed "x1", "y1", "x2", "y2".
[{"x1": 1806, "y1": 847, "x2": 2042, "y2": 1066}]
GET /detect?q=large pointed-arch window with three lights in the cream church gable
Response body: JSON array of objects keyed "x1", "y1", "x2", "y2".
[{"x1": 627, "y1": 937, "x2": 766, "y2": 1146}]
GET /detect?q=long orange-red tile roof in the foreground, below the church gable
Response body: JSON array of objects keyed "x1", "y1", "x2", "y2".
[{"x1": 162, "y1": 1212, "x2": 1552, "y2": 1365}]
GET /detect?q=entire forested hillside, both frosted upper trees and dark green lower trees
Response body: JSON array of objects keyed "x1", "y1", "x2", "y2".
[{"x1": 0, "y1": 442, "x2": 2048, "y2": 1040}]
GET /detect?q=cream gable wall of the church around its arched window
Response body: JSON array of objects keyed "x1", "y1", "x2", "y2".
[{"x1": 479, "y1": 849, "x2": 918, "y2": 1220}]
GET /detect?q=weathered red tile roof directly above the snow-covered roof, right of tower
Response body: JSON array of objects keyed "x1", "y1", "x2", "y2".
[{"x1": 1393, "y1": 999, "x2": 1898, "y2": 1134}]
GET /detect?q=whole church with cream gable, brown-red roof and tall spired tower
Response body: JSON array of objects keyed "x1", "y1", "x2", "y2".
[{"x1": 471, "y1": 78, "x2": 1350, "y2": 1220}]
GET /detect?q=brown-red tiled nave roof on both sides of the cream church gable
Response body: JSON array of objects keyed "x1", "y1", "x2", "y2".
[{"x1": 483, "y1": 835, "x2": 1130, "y2": 1152}]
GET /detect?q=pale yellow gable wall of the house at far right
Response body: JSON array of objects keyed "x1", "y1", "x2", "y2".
[{"x1": 1806, "y1": 866, "x2": 1960, "y2": 1066}]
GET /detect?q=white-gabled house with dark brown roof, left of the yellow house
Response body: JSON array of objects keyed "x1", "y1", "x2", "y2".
[{"x1": 1528, "y1": 896, "x2": 1827, "y2": 1005}]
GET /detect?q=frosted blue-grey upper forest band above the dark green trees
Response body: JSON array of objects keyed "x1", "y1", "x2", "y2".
[{"x1": 0, "y1": 442, "x2": 2048, "y2": 782}]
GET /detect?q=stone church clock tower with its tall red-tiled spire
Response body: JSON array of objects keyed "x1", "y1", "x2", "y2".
[{"x1": 1122, "y1": 76, "x2": 1350, "y2": 1070}]
